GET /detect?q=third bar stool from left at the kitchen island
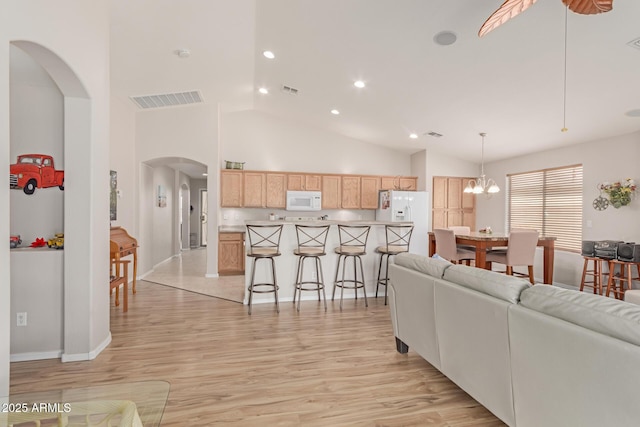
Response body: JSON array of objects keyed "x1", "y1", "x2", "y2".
[{"x1": 331, "y1": 224, "x2": 371, "y2": 310}]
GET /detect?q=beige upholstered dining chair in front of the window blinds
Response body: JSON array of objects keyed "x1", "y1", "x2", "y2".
[{"x1": 486, "y1": 229, "x2": 539, "y2": 285}]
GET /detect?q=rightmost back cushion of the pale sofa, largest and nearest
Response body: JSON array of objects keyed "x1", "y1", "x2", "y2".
[{"x1": 520, "y1": 285, "x2": 640, "y2": 345}]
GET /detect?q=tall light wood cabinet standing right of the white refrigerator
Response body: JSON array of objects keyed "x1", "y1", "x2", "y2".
[{"x1": 432, "y1": 176, "x2": 476, "y2": 230}]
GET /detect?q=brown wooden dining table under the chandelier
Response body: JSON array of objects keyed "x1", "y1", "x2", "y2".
[{"x1": 429, "y1": 231, "x2": 556, "y2": 285}]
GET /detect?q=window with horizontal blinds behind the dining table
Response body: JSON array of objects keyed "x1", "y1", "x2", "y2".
[{"x1": 507, "y1": 165, "x2": 582, "y2": 252}]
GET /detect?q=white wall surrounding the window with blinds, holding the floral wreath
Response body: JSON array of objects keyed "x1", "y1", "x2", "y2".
[{"x1": 477, "y1": 132, "x2": 640, "y2": 285}]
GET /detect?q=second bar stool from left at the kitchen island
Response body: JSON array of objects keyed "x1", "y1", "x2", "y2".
[{"x1": 293, "y1": 224, "x2": 329, "y2": 311}]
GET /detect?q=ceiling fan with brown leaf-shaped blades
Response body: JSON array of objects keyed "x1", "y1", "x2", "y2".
[{"x1": 478, "y1": 0, "x2": 613, "y2": 37}]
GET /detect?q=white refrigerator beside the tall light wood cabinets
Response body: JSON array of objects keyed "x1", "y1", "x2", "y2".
[{"x1": 376, "y1": 190, "x2": 429, "y2": 256}]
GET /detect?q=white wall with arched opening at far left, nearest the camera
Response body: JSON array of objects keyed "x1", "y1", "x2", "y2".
[{"x1": 0, "y1": 0, "x2": 110, "y2": 395}]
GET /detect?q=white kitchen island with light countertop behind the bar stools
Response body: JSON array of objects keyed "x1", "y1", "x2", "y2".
[{"x1": 244, "y1": 220, "x2": 416, "y2": 310}]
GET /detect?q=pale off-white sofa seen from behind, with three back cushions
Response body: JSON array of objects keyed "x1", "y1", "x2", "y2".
[{"x1": 389, "y1": 254, "x2": 640, "y2": 427}]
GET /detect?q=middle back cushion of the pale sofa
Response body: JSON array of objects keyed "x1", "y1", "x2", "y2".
[{"x1": 443, "y1": 265, "x2": 531, "y2": 304}]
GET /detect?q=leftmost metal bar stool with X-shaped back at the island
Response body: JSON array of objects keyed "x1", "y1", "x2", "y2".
[{"x1": 247, "y1": 224, "x2": 282, "y2": 314}]
